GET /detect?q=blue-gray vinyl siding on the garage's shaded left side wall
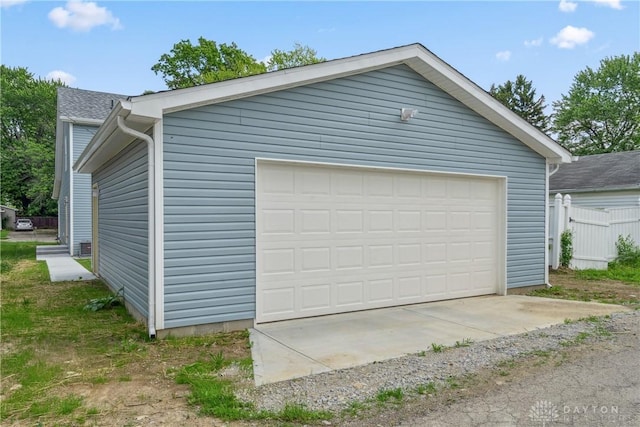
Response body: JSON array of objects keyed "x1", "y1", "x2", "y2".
[{"x1": 93, "y1": 141, "x2": 149, "y2": 317}]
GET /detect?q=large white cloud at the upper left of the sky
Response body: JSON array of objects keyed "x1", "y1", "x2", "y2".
[{"x1": 49, "y1": 0, "x2": 122, "y2": 31}]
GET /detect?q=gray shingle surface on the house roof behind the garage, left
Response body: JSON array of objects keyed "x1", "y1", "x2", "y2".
[{"x1": 58, "y1": 87, "x2": 128, "y2": 121}]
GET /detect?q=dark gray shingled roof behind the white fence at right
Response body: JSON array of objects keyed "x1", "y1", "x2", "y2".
[{"x1": 549, "y1": 150, "x2": 640, "y2": 193}]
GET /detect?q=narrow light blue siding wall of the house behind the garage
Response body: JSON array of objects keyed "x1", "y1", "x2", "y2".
[{"x1": 73, "y1": 125, "x2": 98, "y2": 256}]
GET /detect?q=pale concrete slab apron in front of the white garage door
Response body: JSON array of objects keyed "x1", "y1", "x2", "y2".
[{"x1": 250, "y1": 295, "x2": 626, "y2": 385}]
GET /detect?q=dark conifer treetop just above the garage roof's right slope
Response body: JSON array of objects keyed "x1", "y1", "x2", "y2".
[{"x1": 489, "y1": 74, "x2": 549, "y2": 132}]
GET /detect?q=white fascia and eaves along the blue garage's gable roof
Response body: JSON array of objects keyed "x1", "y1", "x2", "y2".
[{"x1": 74, "y1": 44, "x2": 571, "y2": 172}]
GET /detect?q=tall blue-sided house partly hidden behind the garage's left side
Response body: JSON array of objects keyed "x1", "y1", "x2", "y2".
[{"x1": 53, "y1": 87, "x2": 126, "y2": 256}]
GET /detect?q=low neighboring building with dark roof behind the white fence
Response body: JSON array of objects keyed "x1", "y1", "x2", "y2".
[{"x1": 549, "y1": 150, "x2": 640, "y2": 208}]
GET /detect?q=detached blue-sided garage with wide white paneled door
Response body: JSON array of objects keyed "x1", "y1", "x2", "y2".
[{"x1": 75, "y1": 44, "x2": 571, "y2": 336}]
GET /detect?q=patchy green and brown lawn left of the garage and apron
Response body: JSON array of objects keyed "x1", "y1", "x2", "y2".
[{"x1": 0, "y1": 242, "x2": 331, "y2": 426}]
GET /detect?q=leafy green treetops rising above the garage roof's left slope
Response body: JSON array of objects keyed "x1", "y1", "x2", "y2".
[{"x1": 151, "y1": 37, "x2": 326, "y2": 89}]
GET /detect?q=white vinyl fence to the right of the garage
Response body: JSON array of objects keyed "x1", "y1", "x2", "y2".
[{"x1": 549, "y1": 194, "x2": 640, "y2": 270}]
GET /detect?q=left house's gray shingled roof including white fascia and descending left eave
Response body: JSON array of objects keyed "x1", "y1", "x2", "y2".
[{"x1": 52, "y1": 86, "x2": 127, "y2": 199}]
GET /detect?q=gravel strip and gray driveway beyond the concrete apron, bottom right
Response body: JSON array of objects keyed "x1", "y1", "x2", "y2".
[{"x1": 244, "y1": 311, "x2": 640, "y2": 426}]
